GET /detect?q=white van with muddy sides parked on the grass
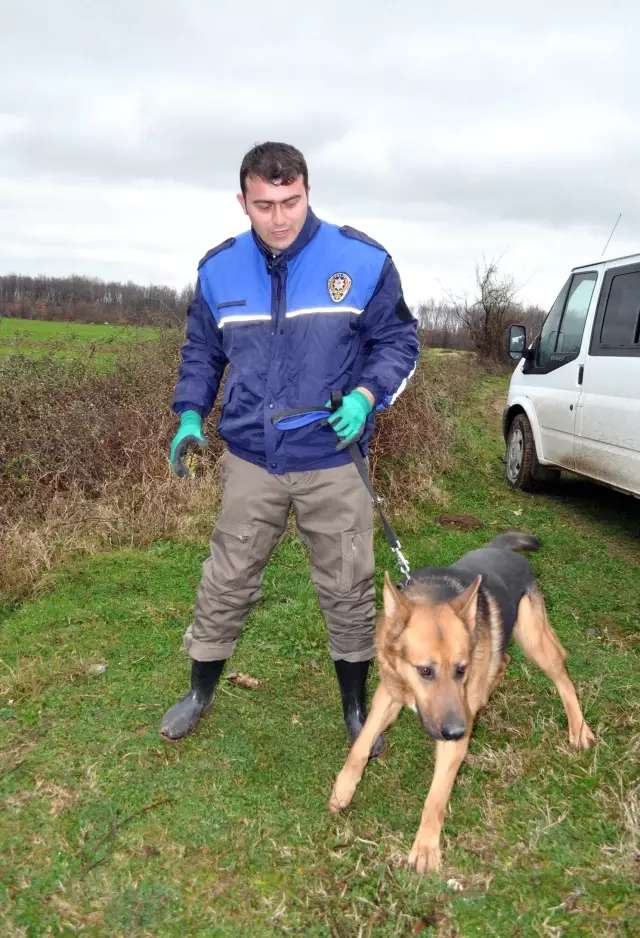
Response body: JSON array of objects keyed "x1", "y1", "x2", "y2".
[{"x1": 503, "y1": 254, "x2": 640, "y2": 497}]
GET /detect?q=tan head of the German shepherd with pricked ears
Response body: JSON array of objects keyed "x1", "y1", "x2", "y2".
[{"x1": 379, "y1": 573, "x2": 482, "y2": 740}]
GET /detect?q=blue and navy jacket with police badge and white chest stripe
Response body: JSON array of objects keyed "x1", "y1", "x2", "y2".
[{"x1": 173, "y1": 210, "x2": 418, "y2": 474}]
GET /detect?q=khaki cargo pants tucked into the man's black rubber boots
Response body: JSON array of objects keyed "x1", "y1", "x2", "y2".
[{"x1": 184, "y1": 451, "x2": 375, "y2": 661}]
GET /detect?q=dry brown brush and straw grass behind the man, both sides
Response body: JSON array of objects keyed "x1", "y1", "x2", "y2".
[{"x1": 0, "y1": 330, "x2": 473, "y2": 598}]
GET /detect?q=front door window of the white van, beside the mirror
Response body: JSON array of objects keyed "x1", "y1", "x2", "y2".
[{"x1": 538, "y1": 271, "x2": 598, "y2": 367}]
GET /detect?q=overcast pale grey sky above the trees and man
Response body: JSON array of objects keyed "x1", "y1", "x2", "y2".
[{"x1": 0, "y1": 0, "x2": 640, "y2": 307}]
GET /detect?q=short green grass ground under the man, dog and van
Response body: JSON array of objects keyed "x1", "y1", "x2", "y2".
[{"x1": 0, "y1": 370, "x2": 640, "y2": 938}]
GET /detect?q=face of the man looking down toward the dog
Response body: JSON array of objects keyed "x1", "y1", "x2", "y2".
[{"x1": 238, "y1": 176, "x2": 309, "y2": 254}]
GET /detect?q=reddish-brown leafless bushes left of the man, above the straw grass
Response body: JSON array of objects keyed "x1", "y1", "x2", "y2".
[{"x1": 0, "y1": 330, "x2": 216, "y2": 524}]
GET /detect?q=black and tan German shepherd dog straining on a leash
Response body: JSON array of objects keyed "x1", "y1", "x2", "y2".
[{"x1": 329, "y1": 531, "x2": 595, "y2": 873}]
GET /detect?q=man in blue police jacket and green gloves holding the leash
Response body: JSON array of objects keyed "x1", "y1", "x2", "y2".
[{"x1": 160, "y1": 143, "x2": 418, "y2": 754}]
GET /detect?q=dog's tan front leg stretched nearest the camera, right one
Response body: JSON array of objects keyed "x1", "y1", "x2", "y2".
[{"x1": 408, "y1": 735, "x2": 469, "y2": 874}]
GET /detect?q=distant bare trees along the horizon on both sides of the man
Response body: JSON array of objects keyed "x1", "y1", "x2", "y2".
[{"x1": 0, "y1": 260, "x2": 546, "y2": 360}]
